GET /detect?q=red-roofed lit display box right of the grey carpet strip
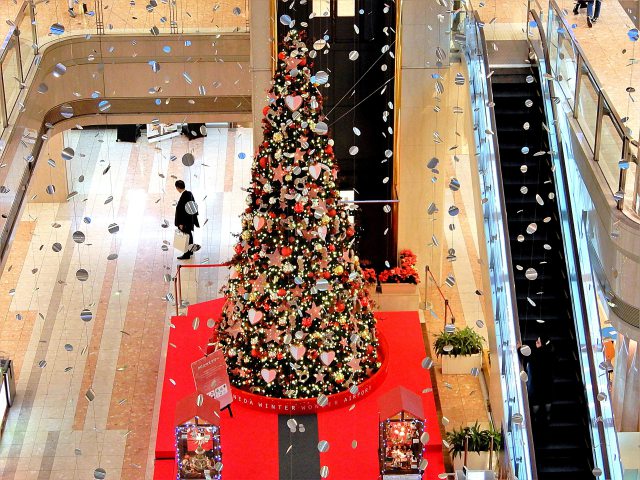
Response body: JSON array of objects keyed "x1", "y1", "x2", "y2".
[{"x1": 378, "y1": 387, "x2": 429, "y2": 480}]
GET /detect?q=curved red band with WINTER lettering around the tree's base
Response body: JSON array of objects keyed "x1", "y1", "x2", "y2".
[{"x1": 231, "y1": 333, "x2": 389, "y2": 415}]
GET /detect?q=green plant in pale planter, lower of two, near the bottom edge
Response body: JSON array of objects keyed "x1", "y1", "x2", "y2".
[{"x1": 445, "y1": 422, "x2": 502, "y2": 470}]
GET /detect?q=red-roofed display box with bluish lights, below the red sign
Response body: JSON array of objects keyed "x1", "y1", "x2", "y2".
[{"x1": 175, "y1": 394, "x2": 222, "y2": 480}]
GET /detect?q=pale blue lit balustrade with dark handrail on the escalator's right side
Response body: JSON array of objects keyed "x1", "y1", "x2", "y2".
[{"x1": 528, "y1": 1, "x2": 623, "y2": 480}]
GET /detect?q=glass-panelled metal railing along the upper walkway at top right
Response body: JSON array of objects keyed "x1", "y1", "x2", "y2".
[{"x1": 530, "y1": 0, "x2": 640, "y2": 214}]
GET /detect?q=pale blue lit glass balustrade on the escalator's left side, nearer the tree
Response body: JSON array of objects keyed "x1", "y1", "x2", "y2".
[{"x1": 465, "y1": 12, "x2": 538, "y2": 480}]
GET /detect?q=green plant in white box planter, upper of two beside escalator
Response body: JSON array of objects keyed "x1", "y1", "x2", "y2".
[{"x1": 433, "y1": 327, "x2": 484, "y2": 375}]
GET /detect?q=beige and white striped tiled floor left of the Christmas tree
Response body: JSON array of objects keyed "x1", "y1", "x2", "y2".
[{"x1": 0, "y1": 125, "x2": 252, "y2": 480}]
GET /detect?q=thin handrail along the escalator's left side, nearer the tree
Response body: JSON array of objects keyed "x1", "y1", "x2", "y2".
[{"x1": 473, "y1": 10, "x2": 538, "y2": 480}]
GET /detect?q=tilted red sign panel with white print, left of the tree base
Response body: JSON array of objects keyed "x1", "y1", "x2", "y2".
[{"x1": 191, "y1": 350, "x2": 233, "y2": 408}]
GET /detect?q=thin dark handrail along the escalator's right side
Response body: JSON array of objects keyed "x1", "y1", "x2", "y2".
[{"x1": 527, "y1": 6, "x2": 619, "y2": 478}]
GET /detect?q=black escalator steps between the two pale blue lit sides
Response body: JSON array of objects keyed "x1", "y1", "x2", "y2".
[{"x1": 492, "y1": 67, "x2": 594, "y2": 480}]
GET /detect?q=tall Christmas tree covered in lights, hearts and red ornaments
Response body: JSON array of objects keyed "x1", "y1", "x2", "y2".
[{"x1": 217, "y1": 30, "x2": 380, "y2": 398}]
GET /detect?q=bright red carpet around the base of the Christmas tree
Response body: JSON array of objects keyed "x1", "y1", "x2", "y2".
[{"x1": 154, "y1": 299, "x2": 444, "y2": 480}]
